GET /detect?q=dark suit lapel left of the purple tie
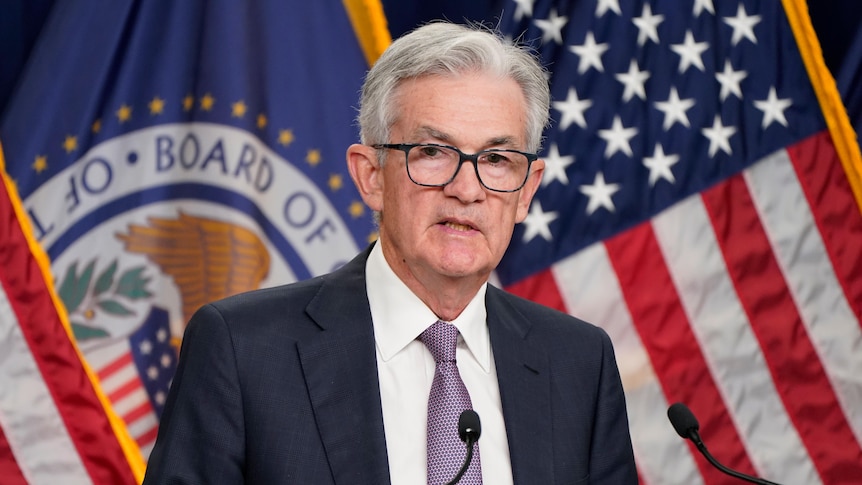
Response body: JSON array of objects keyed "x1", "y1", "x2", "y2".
[{"x1": 299, "y1": 251, "x2": 389, "y2": 485}]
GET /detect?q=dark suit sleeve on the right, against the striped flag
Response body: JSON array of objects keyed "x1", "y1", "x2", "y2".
[{"x1": 590, "y1": 330, "x2": 638, "y2": 485}]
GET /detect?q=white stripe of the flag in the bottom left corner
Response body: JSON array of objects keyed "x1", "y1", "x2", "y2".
[{"x1": 0, "y1": 287, "x2": 92, "y2": 484}]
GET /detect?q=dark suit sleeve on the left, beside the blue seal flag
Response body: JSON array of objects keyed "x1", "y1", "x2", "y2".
[{"x1": 144, "y1": 305, "x2": 245, "y2": 485}]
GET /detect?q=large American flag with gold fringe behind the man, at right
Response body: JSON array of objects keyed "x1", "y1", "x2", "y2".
[{"x1": 498, "y1": 0, "x2": 862, "y2": 485}]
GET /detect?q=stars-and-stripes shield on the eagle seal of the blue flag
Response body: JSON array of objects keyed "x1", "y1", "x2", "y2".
[{"x1": 87, "y1": 308, "x2": 177, "y2": 456}]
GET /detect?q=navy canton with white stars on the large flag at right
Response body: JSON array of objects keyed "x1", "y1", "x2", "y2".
[{"x1": 500, "y1": 0, "x2": 825, "y2": 284}]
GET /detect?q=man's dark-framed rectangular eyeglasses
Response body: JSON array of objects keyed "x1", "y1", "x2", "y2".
[{"x1": 371, "y1": 143, "x2": 539, "y2": 192}]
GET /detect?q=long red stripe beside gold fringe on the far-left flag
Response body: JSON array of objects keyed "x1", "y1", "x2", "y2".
[{"x1": 0, "y1": 175, "x2": 137, "y2": 484}]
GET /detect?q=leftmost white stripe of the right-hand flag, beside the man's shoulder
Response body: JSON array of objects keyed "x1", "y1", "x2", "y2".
[{"x1": 552, "y1": 243, "x2": 703, "y2": 485}]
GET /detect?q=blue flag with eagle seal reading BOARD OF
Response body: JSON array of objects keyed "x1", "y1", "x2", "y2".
[{"x1": 0, "y1": 0, "x2": 382, "y2": 462}]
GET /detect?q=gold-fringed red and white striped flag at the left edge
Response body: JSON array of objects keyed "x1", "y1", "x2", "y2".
[{"x1": 0, "y1": 149, "x2": 144, "y2": 485}]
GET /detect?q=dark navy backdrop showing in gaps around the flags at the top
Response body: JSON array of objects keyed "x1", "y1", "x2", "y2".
[{"x1": 0, "y1": 0, "x2": 862, "y2": 133}]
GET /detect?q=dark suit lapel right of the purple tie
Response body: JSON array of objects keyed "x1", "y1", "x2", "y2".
[{"x1": 486, "y1": 286, "x2": 553, "y2": 483}]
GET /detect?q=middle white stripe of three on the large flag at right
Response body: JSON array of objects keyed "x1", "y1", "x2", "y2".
[{"x1": 652, "y1": 187, "x2": 821, "y2": 485}]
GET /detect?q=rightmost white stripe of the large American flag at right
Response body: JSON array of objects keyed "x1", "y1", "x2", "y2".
[{"x1": 744, "y1": 150, "x2": 862, "y2": 443}]
